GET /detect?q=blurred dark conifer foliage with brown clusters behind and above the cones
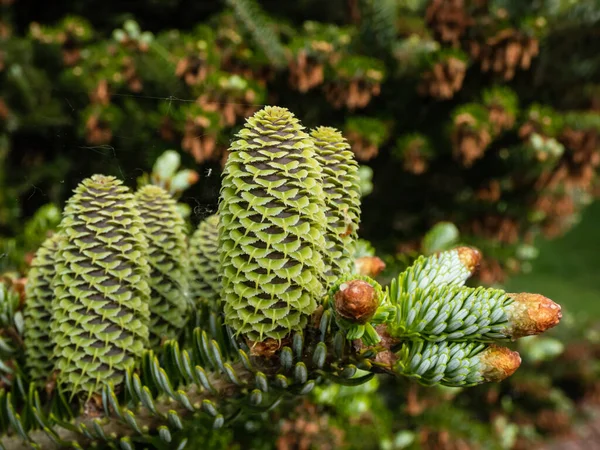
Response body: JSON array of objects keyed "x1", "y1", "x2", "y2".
[{"x1": 0, "y1": 0, "x2": 600, "y2": 284}]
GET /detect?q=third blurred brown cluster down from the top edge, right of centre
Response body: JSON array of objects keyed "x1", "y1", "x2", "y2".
[{"x1": 451, "y1": 113, "x2": 492, "y2": 167}]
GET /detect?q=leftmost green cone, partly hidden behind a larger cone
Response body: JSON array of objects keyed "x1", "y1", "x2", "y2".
[{"x1": 24, "y1": 233, "x2": 62, "y2": 383}]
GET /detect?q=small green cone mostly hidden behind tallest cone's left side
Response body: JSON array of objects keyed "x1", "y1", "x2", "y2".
[{"x1": 190, "y1": 214, "x2": 221, "y2": 309}]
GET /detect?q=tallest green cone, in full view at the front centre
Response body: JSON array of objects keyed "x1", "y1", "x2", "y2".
[{"x1": 219, "y1": 106, "x2": 326, "y2": 341}]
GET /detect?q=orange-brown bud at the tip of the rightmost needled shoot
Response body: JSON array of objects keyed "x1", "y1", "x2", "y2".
[{"x1": 507, "y1": 293, "x2": 562, "y2": 339}]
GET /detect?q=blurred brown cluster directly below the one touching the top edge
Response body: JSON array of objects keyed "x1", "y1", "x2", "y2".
[{"x1": 417, "y1": 58, "x2": 467, "y2": 100}]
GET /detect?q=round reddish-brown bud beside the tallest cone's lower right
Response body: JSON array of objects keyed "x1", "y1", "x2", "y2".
[{"x1": 333, "y1": 280, "x2": 379, "y2": 324}]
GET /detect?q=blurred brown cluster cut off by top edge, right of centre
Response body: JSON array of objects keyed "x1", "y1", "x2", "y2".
[{"x1": 425, "y1": 0, "x2": 473, "y2": 47}]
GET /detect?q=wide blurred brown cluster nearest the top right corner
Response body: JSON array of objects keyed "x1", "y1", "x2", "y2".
[{"x1": 469, "y1": 28, "x2": 539, "y2": 81}]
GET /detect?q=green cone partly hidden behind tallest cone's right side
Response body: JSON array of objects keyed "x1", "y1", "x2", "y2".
[{"x1": 310, "y1": 127, "x2": 360, "y2": 283}]
